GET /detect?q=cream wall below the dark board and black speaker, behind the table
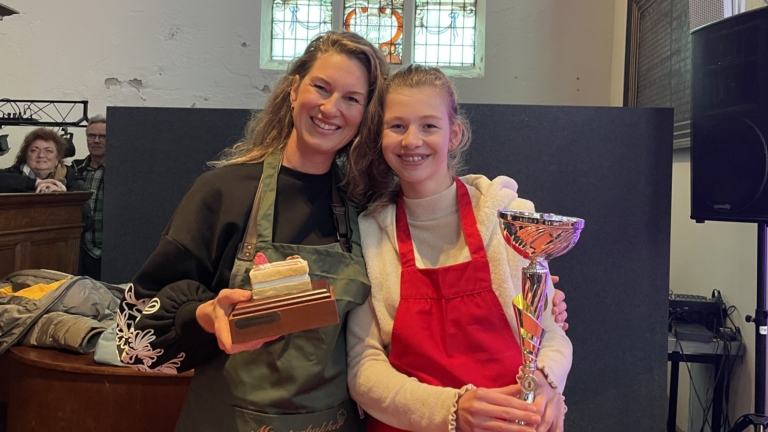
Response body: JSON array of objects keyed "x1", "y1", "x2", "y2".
[{"x1": 670, "y1": 149, "x2": 757, "y2": 431}]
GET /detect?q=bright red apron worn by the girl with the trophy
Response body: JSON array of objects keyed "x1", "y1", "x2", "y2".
[{"x1": 367, "y1": 179, "x2": 523, "y2": 432}]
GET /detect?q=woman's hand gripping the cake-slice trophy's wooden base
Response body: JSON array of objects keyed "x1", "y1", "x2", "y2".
[{"x1": 195, "y1": 289, "x2": 280, "y2": 354}]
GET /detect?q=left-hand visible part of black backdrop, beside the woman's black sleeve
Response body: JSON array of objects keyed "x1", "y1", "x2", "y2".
[{"x1": 102, "y1": 107, "x2": 250, "y2": 283}]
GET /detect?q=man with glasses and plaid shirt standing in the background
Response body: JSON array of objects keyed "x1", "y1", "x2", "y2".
[{"x1": 72, "y1": 114, "x2": 107, "y2": 280}]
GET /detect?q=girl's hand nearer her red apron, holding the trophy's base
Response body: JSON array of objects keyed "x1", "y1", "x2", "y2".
[{"x1": 456, "y1": 381, "x2": 546, "y2": 432}]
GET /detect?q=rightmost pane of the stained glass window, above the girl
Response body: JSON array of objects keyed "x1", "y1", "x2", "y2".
[{"x1": 413, "y1": 0, "x2": 476, "y2": 66}]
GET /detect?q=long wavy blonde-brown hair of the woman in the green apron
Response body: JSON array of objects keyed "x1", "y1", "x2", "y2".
[{"x1": 208, "y1": 31, "x2": 388, "y2": 174}]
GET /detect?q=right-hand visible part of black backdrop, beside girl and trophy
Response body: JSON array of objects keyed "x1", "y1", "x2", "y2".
[{"x1": 465, "y1": 105, "x2": 673, "y2": 432}]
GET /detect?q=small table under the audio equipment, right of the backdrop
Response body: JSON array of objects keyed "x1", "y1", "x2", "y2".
[{"x1": 667, "y1": 333, "x2": 741, "y2": 432}]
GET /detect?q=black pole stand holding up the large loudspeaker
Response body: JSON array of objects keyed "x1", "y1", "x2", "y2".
[{"x1": 728, "y1": 222, "x2": 768, "y2": 432}]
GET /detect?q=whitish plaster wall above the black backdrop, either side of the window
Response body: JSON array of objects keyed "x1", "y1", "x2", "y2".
[{"x1": 0, "y1": 0, "x2": 626, "y2": 167}]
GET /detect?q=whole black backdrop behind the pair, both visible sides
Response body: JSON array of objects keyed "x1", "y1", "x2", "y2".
[{"x1": 104, "y1": 104, "x2": 673, "y2": 432}]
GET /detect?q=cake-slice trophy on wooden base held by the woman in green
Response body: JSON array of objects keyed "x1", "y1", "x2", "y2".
[{"x1": 229, "y1": 253, "x2": 339, "y2": 343}]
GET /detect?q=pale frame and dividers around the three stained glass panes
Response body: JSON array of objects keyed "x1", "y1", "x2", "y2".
[{"x1": 259, "y1": 0, "x2": 486, "y2": 78}]
